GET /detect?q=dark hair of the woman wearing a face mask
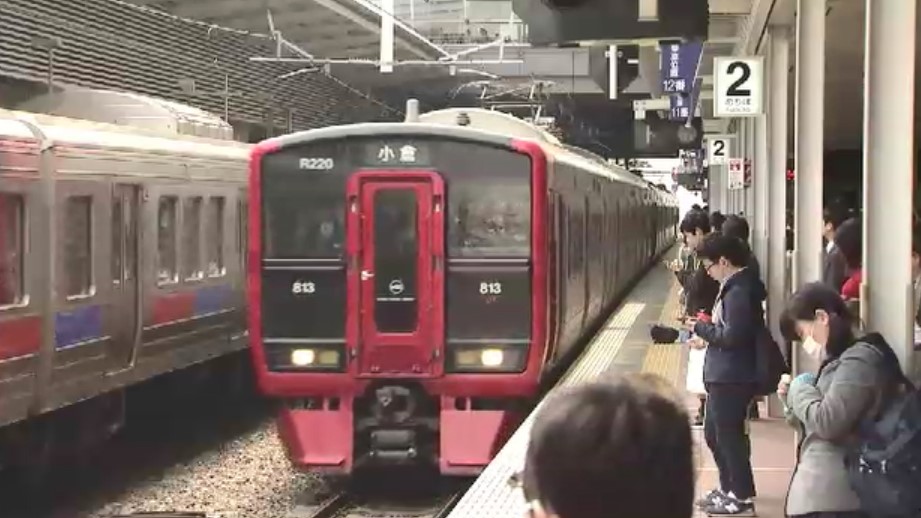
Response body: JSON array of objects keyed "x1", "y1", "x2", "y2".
[{"x1": 780, "y1": 282, "x2": 854, "y2": 360}]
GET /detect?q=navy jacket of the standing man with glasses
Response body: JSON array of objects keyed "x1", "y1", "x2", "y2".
[{"x1": 694, "y1": 268, "x2": 767, "y2": 383}]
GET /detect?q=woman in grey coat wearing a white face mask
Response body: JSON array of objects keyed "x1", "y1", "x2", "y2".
[{"x1": 777, "y1": 283, "x2": 894, "y2": 518}]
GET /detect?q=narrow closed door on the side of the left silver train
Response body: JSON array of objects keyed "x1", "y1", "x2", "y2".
[{"x1": 108, "y1": 184, "x2": 140, "y2": 372}]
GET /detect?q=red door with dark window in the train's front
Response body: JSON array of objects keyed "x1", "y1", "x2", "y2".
[{"x1": 348, "y1": 170, "x2": 444, "y2": 378}]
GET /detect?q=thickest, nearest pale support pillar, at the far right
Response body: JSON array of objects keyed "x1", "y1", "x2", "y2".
[{"x1": 860, "y1": 0, "x2": 917, "y2": 372}]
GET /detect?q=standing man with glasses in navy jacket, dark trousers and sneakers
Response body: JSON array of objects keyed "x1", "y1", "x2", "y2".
[{"x1": 689, "y1": 234, "x2": 766, "y2": 516}]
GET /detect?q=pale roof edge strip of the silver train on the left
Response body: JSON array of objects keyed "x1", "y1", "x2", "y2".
[{"x1": 0, "y1": 110, "x2": 252, "y2": 161}]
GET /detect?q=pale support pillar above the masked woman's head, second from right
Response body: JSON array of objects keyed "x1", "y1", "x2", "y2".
[{"x1": 793, "y1": 0, "x2": 826, "y2": 287}]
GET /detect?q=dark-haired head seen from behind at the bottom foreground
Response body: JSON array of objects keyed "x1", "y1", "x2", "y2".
[{"x1": 521, "y1": 375, "x2": 694, "y2": 518}]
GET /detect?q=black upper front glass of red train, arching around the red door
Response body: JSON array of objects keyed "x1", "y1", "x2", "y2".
[{"x1": 262, "y1": 138, "x2": 531, "y2": 259}]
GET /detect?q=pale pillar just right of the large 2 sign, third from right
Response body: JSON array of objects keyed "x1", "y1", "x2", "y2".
[{"x1": 767, "y1": 26, "x2": 790, "y2": 346}]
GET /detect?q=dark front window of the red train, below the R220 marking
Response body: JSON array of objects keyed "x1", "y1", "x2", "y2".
[{"x1": 262, "y1": 170, "x2": 346, "y2": 259}]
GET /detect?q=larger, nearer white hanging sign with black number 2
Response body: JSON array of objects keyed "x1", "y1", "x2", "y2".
[{"x1": 713, "y1": 56, "x2": 764, "y2": 118}]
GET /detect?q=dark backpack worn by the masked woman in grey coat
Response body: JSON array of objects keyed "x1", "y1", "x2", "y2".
[{"x1": 847, "y1": 335, "x2": 921, "y2": 518}]
